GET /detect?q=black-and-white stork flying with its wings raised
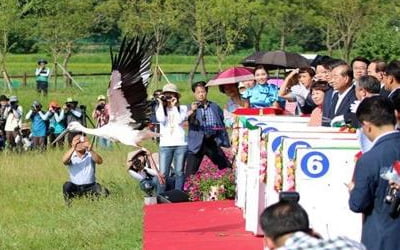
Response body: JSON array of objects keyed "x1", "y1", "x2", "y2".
[{"x1": 55, "y1": 37, "x2": 158, "y2": 147}]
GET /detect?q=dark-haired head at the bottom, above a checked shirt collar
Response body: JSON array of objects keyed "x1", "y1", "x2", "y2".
[{"x1": 260, "y1": 201, "x2": 310, "y2": 240}]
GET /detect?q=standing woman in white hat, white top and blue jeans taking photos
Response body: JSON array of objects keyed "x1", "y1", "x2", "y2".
[{"x1": 156, "y1": 83, "x2": 187, "y2": 192}]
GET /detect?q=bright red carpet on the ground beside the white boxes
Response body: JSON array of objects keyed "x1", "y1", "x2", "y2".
[{"x1": 143, "y1": 200, "x2": 263, "y2": 250}]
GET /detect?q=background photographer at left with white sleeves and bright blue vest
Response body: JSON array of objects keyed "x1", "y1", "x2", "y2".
[{"x1": 25, "y1": 101, "x2": 50, "y2": 150}]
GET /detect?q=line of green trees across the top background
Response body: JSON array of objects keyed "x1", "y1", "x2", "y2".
[{"x1": 0, "y1": 0, "x2": 400, "y2": 83}]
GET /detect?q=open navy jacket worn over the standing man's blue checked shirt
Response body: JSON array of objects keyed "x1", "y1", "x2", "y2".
[{"x1": 188, "y1": 101, "x2": 230, "y2": 154}]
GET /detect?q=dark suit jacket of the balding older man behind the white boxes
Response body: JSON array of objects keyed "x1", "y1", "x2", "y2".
[{"x1": 322, "y1": 85, "x2": 359, "y2": 127}]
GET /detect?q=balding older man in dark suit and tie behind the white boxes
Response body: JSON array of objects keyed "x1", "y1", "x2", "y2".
[{"x1": 322, "y1": 63, "x2": 358, "y2": 127}]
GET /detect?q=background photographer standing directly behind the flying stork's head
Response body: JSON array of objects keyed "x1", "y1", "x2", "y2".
[{"x1": 63, "y1": 97, "x2": 86, "y2": 146}]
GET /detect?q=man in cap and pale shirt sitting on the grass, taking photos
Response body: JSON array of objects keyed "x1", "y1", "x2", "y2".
[{"x1": 62, "y1": 135, "x2": 109, "y2": 205}]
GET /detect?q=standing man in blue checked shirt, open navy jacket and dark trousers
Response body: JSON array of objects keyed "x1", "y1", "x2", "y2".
[{"x1": 185, "y1": 82, "x2": 231, "y2": 177}]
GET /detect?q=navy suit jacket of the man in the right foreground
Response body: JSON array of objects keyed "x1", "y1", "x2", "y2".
[{"x1": 349, "y1": 132, "x2": 400, "y2": 250}]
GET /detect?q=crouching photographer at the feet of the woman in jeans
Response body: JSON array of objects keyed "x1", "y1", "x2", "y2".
[{"x1": 126, "y1": 149, "x2": 166, "y2": 197}]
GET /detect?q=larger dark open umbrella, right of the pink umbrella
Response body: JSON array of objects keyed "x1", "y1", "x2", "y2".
[{"x1": 256, "y1": 50, "x2": 310, "y2": 70}]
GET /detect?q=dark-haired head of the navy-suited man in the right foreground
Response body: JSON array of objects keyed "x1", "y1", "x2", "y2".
[{"x1": 356, "y1": 96, "x2": 396, "y2": 127}]
